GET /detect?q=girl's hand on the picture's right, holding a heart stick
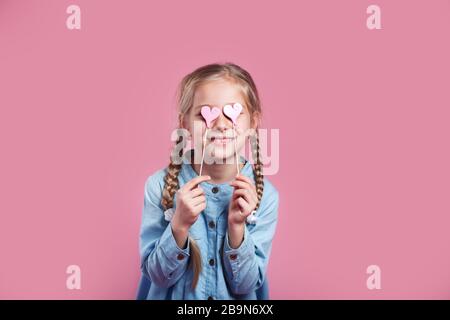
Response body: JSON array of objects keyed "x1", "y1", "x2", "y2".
[{"x1": 228, "y1": 174, "x2": 258, "y2": 225}]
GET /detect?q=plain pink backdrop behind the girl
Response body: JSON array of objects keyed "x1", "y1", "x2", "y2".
[{"x1": 0, "y1": 0, "x2": 450, "y2": 299}]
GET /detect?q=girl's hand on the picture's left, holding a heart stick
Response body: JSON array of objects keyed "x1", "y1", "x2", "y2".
[{"x1": 172, "y1": 176, "x2": 211, "y2": 231}]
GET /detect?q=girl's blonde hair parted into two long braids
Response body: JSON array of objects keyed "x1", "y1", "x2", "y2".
[{"x1": 161, "y1": 63, "x2": 264, "y2": 288}]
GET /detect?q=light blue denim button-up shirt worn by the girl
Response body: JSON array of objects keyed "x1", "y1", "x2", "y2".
[{"x1": 137, "y1": 151, "x2": 278, "y2": 300}]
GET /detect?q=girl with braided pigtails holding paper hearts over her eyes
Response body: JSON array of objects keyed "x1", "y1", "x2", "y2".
[{"x1": 137, "y1": 63, "x2": 278, "y2": 300}]
